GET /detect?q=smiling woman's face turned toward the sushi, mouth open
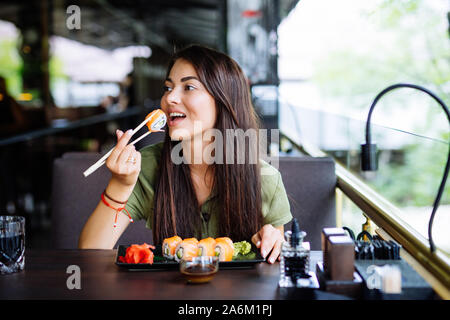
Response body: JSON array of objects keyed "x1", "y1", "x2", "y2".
[{"x1": 161, "y1": 59, "x2": 217, "y2": 140}]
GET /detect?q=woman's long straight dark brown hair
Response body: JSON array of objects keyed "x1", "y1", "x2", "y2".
[{"x1": 153, "y1": 45, "x2": 262, "y2": 244}]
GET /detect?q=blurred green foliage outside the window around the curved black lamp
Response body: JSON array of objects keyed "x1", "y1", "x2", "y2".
[{"x1": 313, "y1": 0, "x2": 450, "y2": 207}]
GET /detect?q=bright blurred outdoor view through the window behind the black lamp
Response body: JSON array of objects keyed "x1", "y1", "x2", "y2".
[{"x1": 280, "y1": 0, "x2": 450, "y2": 252}]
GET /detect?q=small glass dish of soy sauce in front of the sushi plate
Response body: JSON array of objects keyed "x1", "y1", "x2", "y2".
[{"x1": 180, "y1": 256, "x2": 219, "y2": 283}]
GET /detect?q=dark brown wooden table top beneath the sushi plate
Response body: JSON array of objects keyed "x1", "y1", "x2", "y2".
[{"x1": 0, "y1": 249, "x2": 346, "y2": 300}]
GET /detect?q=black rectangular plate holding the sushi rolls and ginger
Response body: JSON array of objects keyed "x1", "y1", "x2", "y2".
[{"x1": 115, "y1": 244, "x2": 266, "y2": 271}]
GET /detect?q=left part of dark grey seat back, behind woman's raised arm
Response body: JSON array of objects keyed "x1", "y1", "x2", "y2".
[{"x1": 52, "y1": 153, "x2": 152, "y2": 249}]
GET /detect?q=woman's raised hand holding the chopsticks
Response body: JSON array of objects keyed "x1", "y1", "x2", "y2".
[{"x1": 106, "y1": 130, "x2": 141, "y2": 189}]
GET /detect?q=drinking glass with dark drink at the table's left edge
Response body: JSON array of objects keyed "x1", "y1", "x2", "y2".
[{"x1": 0, "y1": 216, "x2": 25, "y2": 274}]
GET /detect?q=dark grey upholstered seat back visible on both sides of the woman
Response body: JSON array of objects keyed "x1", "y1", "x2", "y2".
[{"x1": 52, "y1": 153, "x2": 336, "y2": 250}]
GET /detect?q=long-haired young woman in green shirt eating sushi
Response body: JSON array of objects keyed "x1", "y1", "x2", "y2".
[{"x1": 79, "y1": 46, "x2": 292, "y2": 263}]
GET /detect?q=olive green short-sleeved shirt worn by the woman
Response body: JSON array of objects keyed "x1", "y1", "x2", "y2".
[{"x1": 125, "y1": 142, "x2": 292, "y2": 238}]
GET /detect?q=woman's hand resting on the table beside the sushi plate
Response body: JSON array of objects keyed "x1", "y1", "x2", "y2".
[{"x1": 252, "y1": 224, "x2": 284, "y2": 263}]
